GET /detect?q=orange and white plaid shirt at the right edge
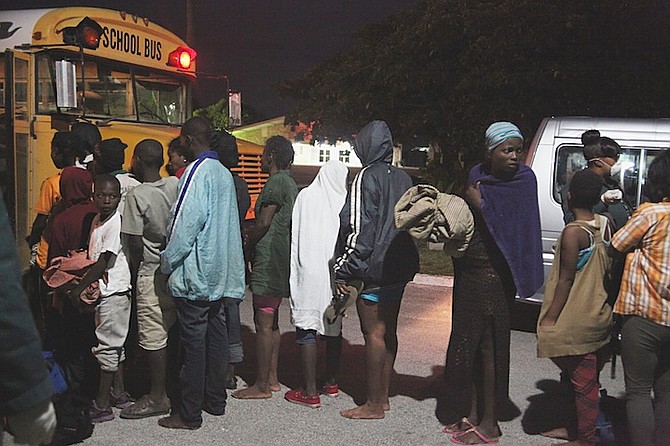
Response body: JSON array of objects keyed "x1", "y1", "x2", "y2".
[{"x1": 612, "y1": 201, "x2": 670, "y2": 326}]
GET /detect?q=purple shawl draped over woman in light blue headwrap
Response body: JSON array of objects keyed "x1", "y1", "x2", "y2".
[{"x1": 468, "y1": 164, "x2": 544, "y2": 297}]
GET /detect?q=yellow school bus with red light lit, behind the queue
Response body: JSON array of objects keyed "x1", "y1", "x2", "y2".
[{"x1": 0, "y1": 7, "x2": 262, "y2": 265}]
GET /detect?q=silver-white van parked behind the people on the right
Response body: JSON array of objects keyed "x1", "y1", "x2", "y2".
[{"x1": 526, "y1": 117, "x2": 670, "y2": 302}]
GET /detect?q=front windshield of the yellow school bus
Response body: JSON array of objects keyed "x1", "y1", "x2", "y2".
[{"x1": 37, "y1": 53, "x2": 188, "y2": 125}]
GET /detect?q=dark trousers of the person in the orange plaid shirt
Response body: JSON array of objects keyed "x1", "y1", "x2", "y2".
[{"x1": 621, "y1": 316, "x2": 670, "y2": 446}]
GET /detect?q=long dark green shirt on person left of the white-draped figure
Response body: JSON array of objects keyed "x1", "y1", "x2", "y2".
[{"x1": 251, "y1": 170, "x2": 298, "y2": 297}]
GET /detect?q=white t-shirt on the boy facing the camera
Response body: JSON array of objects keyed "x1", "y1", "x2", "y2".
[{"x1": 88, "y1": 210, "x2": 130, "y2": 297}]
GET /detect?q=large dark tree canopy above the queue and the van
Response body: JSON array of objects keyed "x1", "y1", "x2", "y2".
[{"x1": 278, "y1": 0, "x2": 670, "y2": 186}]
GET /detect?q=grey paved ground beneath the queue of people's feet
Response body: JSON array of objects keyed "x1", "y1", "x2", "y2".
[{"x1": 9, "y1": 276, "x2": 623, "y2": 446}]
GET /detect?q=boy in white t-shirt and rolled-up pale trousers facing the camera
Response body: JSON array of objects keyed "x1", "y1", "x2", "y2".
[{"x1": 71, "y1": 174, "x2": 132, "y2": 423}]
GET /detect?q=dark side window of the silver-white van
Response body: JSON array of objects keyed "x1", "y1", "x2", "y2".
[{"x1": 553, "y1": 145, "x2": 664, "y2": 208}]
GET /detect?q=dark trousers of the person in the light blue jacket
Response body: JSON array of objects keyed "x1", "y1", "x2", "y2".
[{"x1": 177, "y1": 299, "x2": 230, "y2": 426}]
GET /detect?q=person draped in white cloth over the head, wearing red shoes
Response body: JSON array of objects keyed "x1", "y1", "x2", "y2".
[{"x1": 284, "y1": 160, "x2": 348, "y2": 408}]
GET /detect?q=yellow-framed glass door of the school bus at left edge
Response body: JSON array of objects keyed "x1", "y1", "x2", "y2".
[{"x1": 0, "y1": 50, "x2": 34, "y2": 264}]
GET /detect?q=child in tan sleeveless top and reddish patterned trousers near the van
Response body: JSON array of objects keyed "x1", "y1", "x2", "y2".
[{"x1": 537, "y1": 170, "x2": 612, "y2": 446}]
